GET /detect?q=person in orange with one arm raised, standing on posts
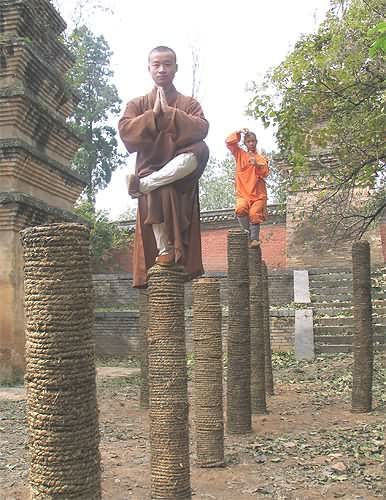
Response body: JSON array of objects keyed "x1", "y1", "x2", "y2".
[{"x1": 226, "y1": 129, "x2": 269, "y2": 248}]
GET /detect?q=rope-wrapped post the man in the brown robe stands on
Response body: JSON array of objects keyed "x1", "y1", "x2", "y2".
[{"x1": 148, "y1": 265, "x2": 191, "y2": 500}]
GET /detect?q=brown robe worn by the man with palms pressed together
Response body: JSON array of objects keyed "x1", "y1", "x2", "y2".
[{"x1": 118, "y1": 87, "x2": 209, "y2": 287}]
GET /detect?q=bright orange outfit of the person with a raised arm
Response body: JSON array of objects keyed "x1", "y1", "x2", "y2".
[{"x1": 225, "y1": 132, "x2": 269, "y2": 224}]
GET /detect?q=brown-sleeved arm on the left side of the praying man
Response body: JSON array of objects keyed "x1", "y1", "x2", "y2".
[{"x1": 118, "y1": 101, "x2": 159, "y2": 153}]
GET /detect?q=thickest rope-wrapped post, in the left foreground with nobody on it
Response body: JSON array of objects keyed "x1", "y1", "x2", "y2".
[{"x1": 22, "y1": 223, "x2": 101, "y2": 500}]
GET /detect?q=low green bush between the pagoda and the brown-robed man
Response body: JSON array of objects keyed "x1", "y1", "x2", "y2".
[{"x1": 74, "y1": 201, "x2": 131, "y2": 266}]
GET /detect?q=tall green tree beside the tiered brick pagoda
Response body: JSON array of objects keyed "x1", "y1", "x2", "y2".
[{"x1": 68, "y1": 26, "x2": 125, "y2": 205}]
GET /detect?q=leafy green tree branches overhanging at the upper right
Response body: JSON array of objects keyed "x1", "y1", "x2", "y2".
[{"x1": 248, "y1": 0, "x2": 386, "y2": 235}]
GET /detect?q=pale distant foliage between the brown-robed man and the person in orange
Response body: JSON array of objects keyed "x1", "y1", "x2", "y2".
[{"x1": 200, "y1": 154, "x2": 235, "y2": 210}]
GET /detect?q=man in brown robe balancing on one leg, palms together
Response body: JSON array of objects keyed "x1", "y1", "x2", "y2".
[{"x1": 118, "y1": 46, "x2": 209, "y2": 287}]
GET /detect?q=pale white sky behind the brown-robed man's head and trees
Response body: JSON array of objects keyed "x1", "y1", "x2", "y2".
[{"x1": 56, "y1": 0, "x2": 329, "y2": 219}]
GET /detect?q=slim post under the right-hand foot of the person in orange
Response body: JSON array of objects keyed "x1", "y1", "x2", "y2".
[{"x1": 248, "y1": 248, "x2": 267, "y2": 415}]
